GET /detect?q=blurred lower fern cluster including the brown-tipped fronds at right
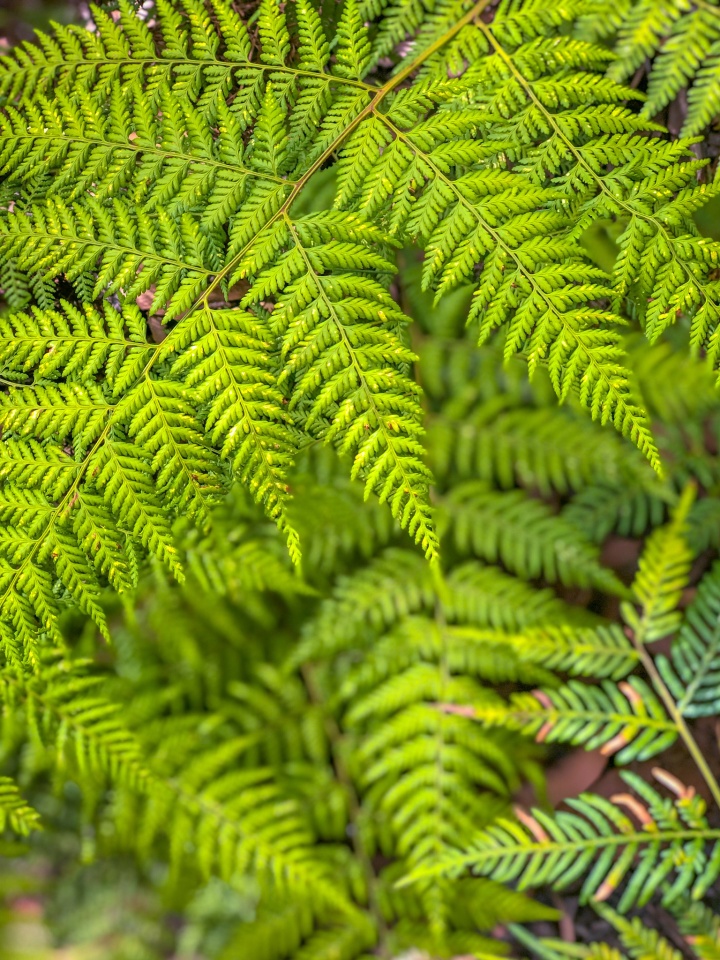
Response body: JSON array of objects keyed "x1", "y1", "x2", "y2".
[{"x1": 3, "y1": 271, "x2": 720, "y2": 958}]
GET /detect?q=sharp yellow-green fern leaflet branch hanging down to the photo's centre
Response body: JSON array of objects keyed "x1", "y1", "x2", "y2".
[{"x1": 238, "y1": 215, "x2": 437, "y2": 557}]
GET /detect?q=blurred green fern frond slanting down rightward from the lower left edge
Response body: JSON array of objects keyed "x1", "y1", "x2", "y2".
[{"x1": 0, "y1": 659, "x2": 353, "y2": 914}]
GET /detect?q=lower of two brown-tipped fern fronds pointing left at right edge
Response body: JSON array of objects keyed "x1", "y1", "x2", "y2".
[{"x1": 411, "y1": 771, "x2": 720, "y2": 911}]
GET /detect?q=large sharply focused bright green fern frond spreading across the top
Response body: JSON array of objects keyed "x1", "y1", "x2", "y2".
[{"x1": 0, "y1": 0, "x2": 717, "y2": 656}]
